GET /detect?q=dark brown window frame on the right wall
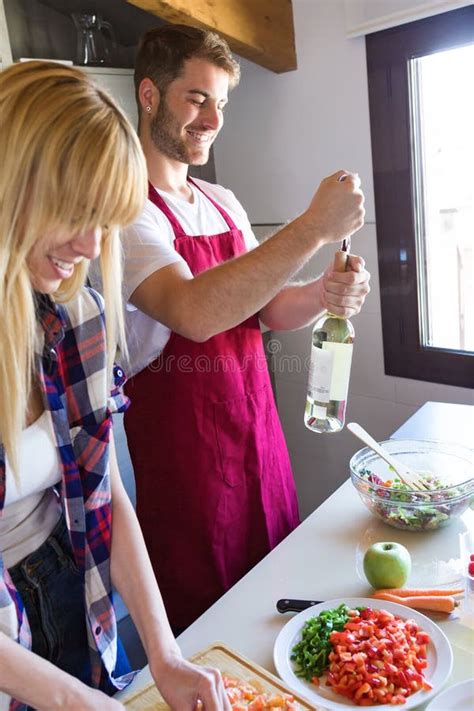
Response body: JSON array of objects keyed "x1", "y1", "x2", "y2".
[{"x1": 366, "y1": 5, "x2": 474, "y2": 388}]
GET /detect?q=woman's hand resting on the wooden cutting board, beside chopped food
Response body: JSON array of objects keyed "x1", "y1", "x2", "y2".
[{"x1": 153, "y1": 655, "x2": 231, "y2": 711}]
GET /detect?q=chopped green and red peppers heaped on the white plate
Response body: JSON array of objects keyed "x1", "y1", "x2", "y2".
[{"x1": 291, "y1": 604, "x2": 432, "y2": 706}]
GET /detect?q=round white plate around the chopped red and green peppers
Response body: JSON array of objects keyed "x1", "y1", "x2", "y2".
[{"x1": 273, "y1": 597, "x2": 453, "y2": 711}]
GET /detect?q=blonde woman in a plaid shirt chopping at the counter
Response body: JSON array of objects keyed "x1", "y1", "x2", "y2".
[{"x1": 0, "y1": 62, "x2": 230, "y2": 711}]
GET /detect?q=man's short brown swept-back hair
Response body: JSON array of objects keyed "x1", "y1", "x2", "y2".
[{"x1": 135, "y1": 25, "x2": 240, "y2": 109}]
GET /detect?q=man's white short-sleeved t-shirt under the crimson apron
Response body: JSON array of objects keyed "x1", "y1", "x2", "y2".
[{"x1": 122, "y1": 178, "x2": 258, "y2": 376}]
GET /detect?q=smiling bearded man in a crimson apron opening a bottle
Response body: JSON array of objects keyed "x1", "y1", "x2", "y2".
[{"x1": 120, "y1": 25, "x2": 369, "y2": 631}]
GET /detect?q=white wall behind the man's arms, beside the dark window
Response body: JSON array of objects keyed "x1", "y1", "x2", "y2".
[{"x1": 215, "y1": 0, "x2": 474, "y2": 515}]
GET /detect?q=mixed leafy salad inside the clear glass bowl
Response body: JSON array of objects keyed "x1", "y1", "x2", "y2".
[{"x1": 359, "y1": 469, "x2": 468, "y2": 531}]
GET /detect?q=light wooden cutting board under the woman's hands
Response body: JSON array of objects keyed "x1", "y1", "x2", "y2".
[{"x1": 123, "y1": 642, "x2": 316, "y2": 711}]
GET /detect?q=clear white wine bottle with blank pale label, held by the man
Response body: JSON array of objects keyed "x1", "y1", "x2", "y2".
[{"x1": 304, "y1": 250, "x2": 354, "y2": 432}]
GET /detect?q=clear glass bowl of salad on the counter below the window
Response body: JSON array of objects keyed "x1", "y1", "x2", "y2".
[{"x1": 350, "y1": 439, "x2": 474, "y2": 531}]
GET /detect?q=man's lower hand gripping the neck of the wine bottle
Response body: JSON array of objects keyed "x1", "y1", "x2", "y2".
[{"x1": 320, "y1": 254, "x2": 370, "y2": 318}]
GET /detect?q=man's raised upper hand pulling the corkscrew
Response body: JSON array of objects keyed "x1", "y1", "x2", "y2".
[{"x1": 304, "y1": 170, "x2": 365, "y2": 243}]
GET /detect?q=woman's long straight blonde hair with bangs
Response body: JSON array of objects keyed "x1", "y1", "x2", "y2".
[{"x1": 0, "y1": 61, "x2": 147, "y2": 469}]
